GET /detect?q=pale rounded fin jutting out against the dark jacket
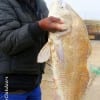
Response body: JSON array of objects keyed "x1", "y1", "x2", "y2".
[{"x1": 37, "y1": 43, "x2": 50, "y2": 63}]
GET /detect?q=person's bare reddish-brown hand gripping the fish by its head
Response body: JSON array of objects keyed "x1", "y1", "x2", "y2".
[{"x1": 38, "y1": 16, "x2": 66, "y2": 32}]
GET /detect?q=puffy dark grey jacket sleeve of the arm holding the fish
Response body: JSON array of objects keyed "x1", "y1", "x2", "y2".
[{"x1": 0, "y1": 0, "x2": 46, "y2": 55}]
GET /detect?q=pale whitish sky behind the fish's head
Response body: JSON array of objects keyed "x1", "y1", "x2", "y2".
[{"x1": 45, "y1": 0, "x2": 100, "y2": 20}]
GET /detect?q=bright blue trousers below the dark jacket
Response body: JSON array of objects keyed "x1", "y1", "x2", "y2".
[{"x1": 0, "y1": 86, "x2": 41, "y2": 100}]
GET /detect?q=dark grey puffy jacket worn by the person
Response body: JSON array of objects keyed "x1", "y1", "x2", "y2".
[{"x1": 0, "y1": 0, "x2": 48, "y2": 91}]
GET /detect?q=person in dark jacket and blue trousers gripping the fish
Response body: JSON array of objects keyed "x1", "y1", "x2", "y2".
[{"x1": 0, "y1": 0, "x2": 64, "y2": 100}]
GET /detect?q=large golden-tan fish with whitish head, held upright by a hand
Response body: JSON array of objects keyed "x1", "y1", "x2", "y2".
[{"x1": 38, "y1": 0, "x2": 91, "y2": 100}]
